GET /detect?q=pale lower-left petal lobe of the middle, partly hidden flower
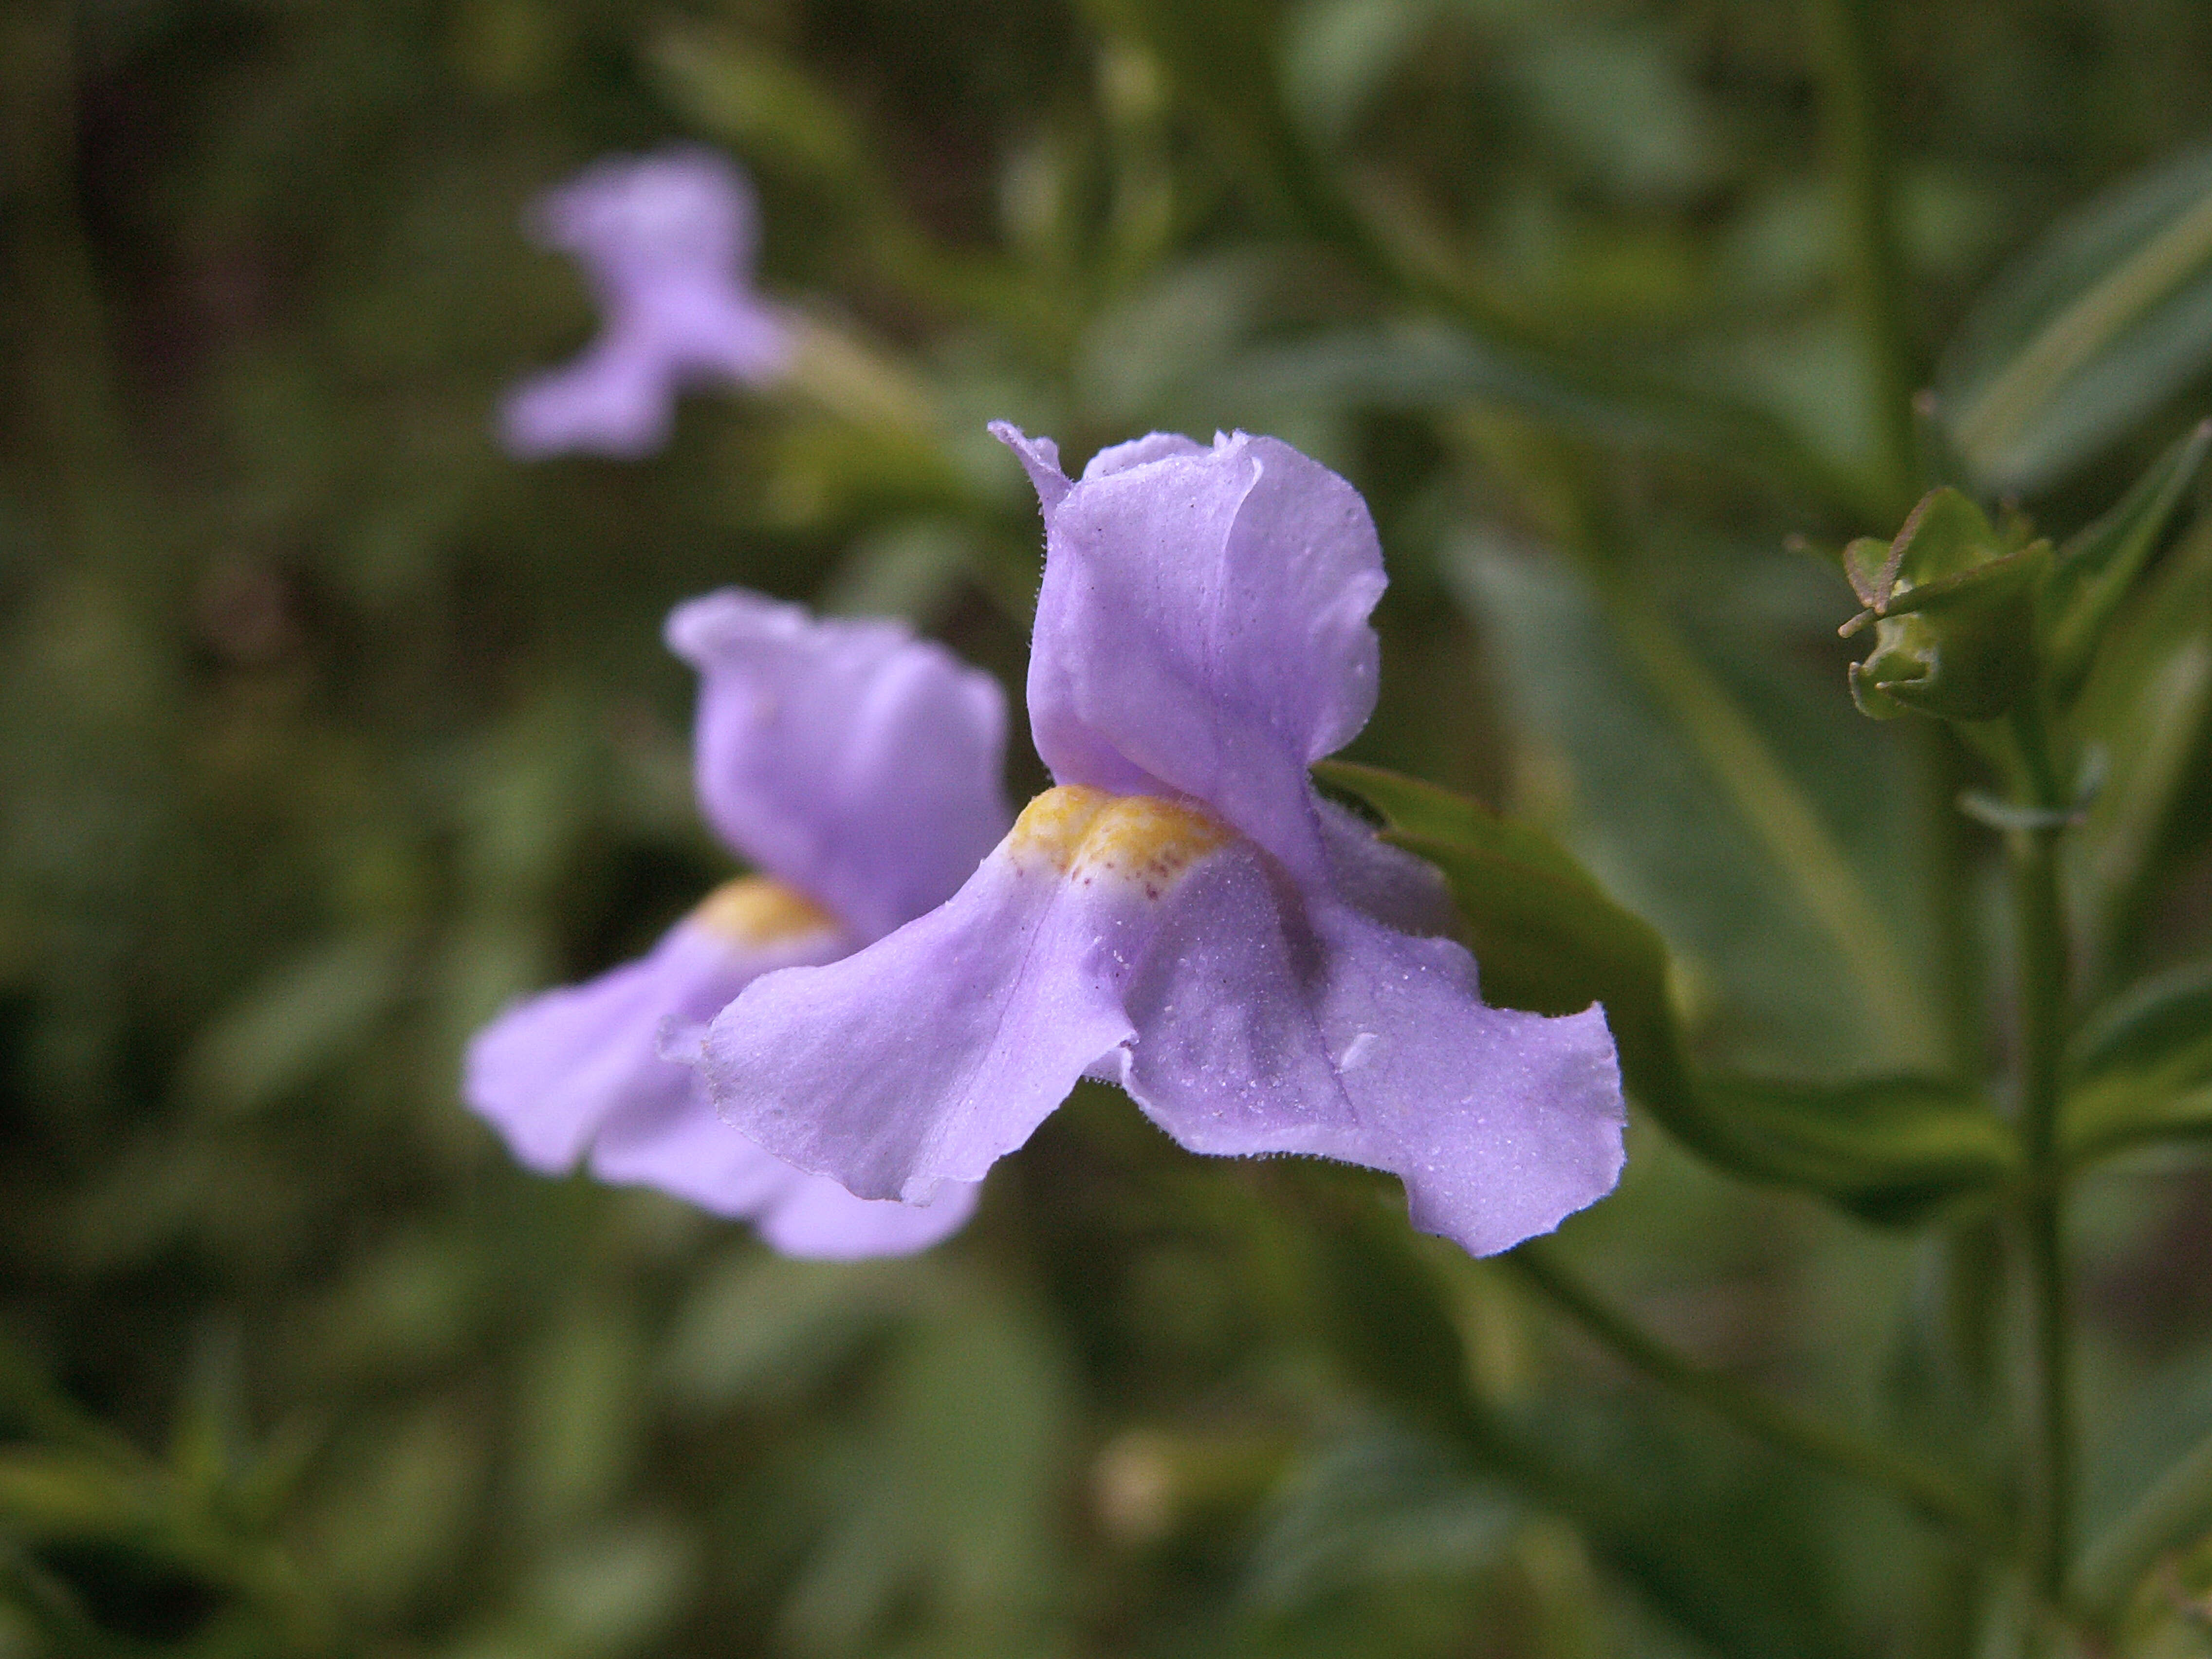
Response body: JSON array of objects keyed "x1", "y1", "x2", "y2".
[{"x1": 462, "y1": 918, "x2": 845, "y2": 1175}]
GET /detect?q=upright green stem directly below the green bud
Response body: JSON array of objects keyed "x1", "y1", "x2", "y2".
[{"x1": 2006, "y1": 710, "x2": 2075, "y2": 1606}]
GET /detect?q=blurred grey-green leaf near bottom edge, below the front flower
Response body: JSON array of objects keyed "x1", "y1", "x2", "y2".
[{"x1": 1243, "y1": 1431, "x2": 1524, "y2": 1613}]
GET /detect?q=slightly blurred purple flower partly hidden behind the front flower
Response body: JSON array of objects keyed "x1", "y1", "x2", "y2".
[{"x1": 475, "y1": 589, "x2": 1011, "y2": 1259}]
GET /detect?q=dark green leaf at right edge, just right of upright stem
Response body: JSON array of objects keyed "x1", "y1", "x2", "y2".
[{"x1": 2066, "y1": 960, "x2": 2212, "y2": 1159}]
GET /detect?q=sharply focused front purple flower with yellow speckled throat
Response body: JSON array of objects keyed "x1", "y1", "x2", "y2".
[{"x1": 701, "y1": 424, "x2": 1623, "y2": 1254}]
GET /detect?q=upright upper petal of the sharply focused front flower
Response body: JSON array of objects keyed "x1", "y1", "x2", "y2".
[{"x1": 993, "y1": 424, "x2": 1382, "y2": 881}]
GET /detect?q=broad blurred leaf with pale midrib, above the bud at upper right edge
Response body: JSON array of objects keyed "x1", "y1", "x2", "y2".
[{"x1": 1940, "y1": 150, "x2": 2212, "y2": 491}]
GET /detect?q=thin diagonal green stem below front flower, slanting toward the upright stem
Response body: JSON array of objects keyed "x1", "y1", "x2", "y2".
[{"x1": 1500, "y1": 1239, "x2": 2004, "y2": 1553}]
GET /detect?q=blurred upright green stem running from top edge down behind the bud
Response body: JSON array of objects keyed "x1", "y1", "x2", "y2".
[{"x1": 1812, "y1": 0, "x2": 1920, "y2": 511}]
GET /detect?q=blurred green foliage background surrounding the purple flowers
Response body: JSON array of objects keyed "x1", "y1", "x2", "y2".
[{"x1": 0, "y1": 0, "x2": 2212, "y2": 1659}]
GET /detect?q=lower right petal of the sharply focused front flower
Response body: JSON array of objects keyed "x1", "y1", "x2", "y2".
[{"x1": 1124, "y1": 858, "x2": 1623, "y2": 1256}]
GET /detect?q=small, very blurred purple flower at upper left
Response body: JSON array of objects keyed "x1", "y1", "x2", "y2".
[{"x1": 500, "y1": 148, "x2": 790, "y2": 460}]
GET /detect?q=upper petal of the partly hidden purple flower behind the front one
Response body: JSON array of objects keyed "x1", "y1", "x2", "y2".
[{"x1": 668, "y1": 589, "x2": 1013, "y2": 938}]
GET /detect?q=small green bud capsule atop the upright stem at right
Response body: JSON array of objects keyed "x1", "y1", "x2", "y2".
[{"x1": 1843, "y1": 489, "x2": 2050, "y2": 721}]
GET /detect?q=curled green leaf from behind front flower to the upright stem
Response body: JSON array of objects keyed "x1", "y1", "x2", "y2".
[{"x1": 1314, "y1": 761, "x2": 2015, "y2": 1225}]
